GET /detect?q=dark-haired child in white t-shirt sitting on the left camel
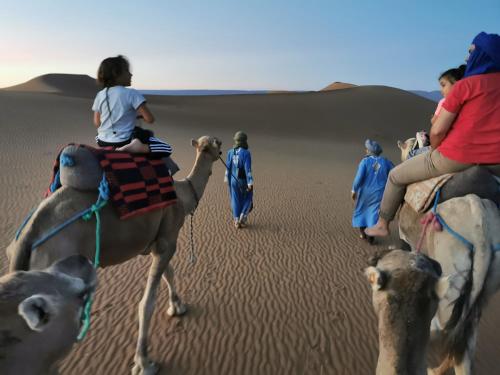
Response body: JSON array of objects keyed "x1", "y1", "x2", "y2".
[{"x1": 92, "y1": 55, "x2": 172, "y2": 157}]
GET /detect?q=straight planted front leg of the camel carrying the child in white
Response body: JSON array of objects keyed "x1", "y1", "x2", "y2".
[{"x1": 132, "y1": 252, "x2": 173, "y2": 375}]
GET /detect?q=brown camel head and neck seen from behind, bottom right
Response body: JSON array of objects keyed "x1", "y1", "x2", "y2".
[{"x1": 365, "y1": 250, "x2": 448, "y2": 375}]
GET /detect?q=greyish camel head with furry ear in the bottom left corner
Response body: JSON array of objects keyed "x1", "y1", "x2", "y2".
[{"x1": 0, "y1": 255, "x2": 96, "y2": 375}]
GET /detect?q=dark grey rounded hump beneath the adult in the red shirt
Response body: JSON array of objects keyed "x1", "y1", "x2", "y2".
[{"x1": 440, "y1": 166, "x2": 500, "y2": 204}]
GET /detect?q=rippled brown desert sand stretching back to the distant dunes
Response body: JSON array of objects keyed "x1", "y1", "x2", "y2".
[{"x1": 0, "y1": 76, "x2": 500, "y2": 375}]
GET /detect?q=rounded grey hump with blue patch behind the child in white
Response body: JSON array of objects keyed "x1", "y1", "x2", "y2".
[{"x1": 59, "y1": 145, "x2": 102, "y2": 190}]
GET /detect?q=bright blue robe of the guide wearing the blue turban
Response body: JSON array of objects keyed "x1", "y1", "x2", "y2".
[{"x1": 352, "y1": 155, "x2": 394, "y2": 228}]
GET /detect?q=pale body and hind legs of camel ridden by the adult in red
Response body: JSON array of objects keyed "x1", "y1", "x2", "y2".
[{"x1": 399, "y1": 194, "x2": 500, "y2": 374}]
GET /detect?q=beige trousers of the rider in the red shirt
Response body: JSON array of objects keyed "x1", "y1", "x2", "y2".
[{"x1": 380, "y1": 150, "x2": 473, "y2": 221}]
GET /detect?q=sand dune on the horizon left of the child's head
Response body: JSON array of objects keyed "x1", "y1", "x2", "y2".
[{"x1": 4, "y1": 74, "x2": 99, "y2": 98}]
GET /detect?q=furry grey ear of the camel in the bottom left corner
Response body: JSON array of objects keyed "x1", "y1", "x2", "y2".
[{"x1": 17, "y1": 294, "x2": 56, "y2": 332}]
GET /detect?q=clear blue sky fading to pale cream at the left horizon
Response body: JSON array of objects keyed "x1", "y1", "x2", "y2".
[{"x1": 0, "y1": 0, "x2": 500, "y2": 90}]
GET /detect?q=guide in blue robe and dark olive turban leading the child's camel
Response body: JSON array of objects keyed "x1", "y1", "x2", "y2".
[{"x1": 224, "y1": 131, "x2": 253, "y2": 229}]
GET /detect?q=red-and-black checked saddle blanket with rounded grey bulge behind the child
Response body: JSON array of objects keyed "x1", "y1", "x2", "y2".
[{"x1": 47, "y1": 144, "x2": 177, "y2": 219}]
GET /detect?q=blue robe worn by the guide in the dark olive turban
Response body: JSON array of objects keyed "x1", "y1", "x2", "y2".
[{"x1": 226, "y1": 147, "x2": 253, "y2": 219}]
